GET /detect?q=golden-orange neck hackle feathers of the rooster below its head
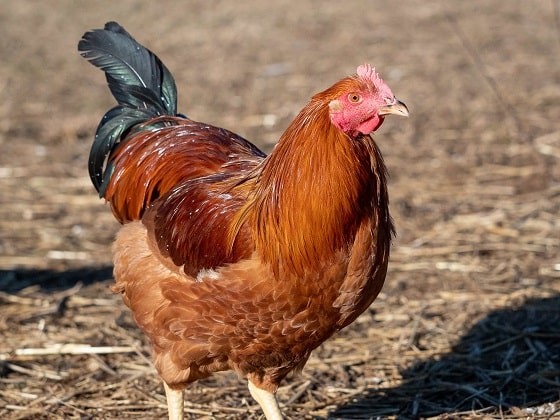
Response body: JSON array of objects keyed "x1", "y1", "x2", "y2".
[{"x1": 247, "y1": 99, "x2": 392, "y2": 276}]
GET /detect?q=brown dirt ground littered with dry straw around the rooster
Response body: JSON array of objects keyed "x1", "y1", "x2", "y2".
[{"x1": 0, "y1": 0, "x2": 560, "y2": 419}]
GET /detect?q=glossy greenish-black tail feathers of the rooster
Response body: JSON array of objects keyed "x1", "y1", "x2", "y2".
[{"x1": 78, "y1": 22, "x2": 177, "y2": 197}]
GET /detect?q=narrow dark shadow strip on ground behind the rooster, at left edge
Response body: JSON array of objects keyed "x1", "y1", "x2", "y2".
[{"x1": 0, "y1": 266, "x2": 113, "y2": 293}]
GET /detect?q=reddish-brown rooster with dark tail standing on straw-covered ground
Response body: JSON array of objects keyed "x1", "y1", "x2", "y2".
[{"x1": 78, "y1": 22, "x2": 408, "y2": 420}]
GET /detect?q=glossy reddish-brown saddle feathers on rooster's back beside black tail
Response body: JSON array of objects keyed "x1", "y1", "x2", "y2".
[{"x1": 105, "y1": 117, "x2": 265, "y2": 223}]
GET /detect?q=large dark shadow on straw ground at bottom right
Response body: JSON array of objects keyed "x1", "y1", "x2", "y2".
[{"x1": 329, "y1": 297, "x2": 560, "y2": 419}]
